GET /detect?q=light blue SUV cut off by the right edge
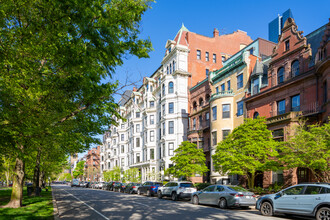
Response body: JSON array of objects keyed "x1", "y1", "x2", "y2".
[{"x1": 256, "y1": 183, "x2": 330, "y2": 220}]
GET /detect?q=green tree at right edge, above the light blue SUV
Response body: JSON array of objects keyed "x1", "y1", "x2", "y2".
[{"x1": 279, "y1": 118, "x2": 330, "y2": 182}]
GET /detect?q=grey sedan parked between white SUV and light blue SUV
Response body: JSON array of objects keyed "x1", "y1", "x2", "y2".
[{"x1": 191, "y1": 185, "x2": 256, "y2": 209}]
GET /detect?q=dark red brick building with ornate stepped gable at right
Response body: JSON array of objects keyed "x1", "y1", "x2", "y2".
[{"x1": 244, "y1": 18, "x2": 330, "y2": 187}]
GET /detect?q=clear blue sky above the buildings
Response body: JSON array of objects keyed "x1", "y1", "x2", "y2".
[{"x1": 81, "y1": 0, "x2": 330, "y2": 158}]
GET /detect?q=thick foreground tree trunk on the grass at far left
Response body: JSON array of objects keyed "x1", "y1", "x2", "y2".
[{"x1": 2, "y1": 158, "x2": 25, "y2": 208}]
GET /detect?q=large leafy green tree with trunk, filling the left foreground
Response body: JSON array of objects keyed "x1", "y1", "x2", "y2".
[{"x1": 0, "y1": 0, "x2": 151, "y2": 208}]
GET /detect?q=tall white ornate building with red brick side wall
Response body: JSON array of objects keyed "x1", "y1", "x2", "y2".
[{"x1": 101, "y1": 25, "x2": 252, "y2": 181}]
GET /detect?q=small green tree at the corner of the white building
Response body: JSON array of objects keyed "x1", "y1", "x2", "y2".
[{"x1": 165, "y1": 141, "x2": 208, "y2": 179}]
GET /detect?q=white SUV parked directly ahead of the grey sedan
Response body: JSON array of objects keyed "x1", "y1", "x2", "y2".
[{"x1": 157, "y1": 181, "x2": 196, "y2": 201}]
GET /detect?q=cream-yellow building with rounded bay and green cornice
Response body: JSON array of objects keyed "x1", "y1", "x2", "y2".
[{"x1": 209, "y1": 38, "x2": 275, "y2": 184}]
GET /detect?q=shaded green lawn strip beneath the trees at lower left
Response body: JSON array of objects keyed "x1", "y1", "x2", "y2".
[{"x1": 0, "y1": 187, "x2": 54, "y2": 220}]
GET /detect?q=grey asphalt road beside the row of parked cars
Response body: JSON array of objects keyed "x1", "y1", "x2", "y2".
[{"x1": 53, "y1": 185, "x2": 312, "y2": 220}]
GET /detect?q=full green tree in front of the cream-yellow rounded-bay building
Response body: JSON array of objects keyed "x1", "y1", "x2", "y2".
[{"x1": 212, "y1": 118, "x2": 279, "y2": 189}]
